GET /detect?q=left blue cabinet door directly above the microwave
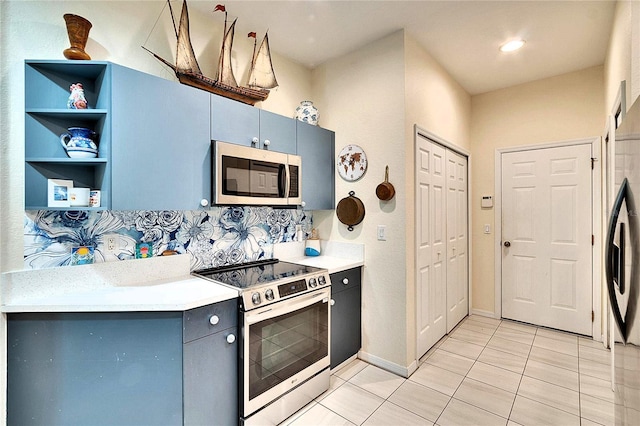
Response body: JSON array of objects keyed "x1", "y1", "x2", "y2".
[{"x1": 211, "y1": 95, "x2": 260, "y2": 146}]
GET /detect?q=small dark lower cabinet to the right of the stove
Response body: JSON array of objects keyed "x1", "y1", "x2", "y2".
[{"x1": 330, "y1": 268, "x2": 362, "y2": 368}]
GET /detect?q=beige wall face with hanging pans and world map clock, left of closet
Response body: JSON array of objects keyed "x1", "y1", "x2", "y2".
[{"x1": 313, "y1": 32, "x2": 407, "y2": 367}]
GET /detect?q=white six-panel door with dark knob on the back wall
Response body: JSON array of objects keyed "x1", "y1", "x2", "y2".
[{"x1": 502, "y1": 144, "x2": 592, "y2": 335}]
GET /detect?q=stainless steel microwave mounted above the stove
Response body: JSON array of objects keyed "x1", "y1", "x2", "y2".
[{"x1": 212, "y1": 141, "x2": 302, "y2": 206}]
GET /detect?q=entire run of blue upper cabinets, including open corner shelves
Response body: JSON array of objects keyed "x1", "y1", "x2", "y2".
[{"x1": 25, "y1": 60, "x2": 335, "y2": 210}]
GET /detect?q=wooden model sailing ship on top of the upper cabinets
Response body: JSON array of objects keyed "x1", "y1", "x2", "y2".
[{"x1": 142, "y1": 0, "x2": 278, "y2": 105}]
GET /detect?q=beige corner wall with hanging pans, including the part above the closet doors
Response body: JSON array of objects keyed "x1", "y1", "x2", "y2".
[{"x1": 313, "y1": 31, "x2": 471, "y2": 371}]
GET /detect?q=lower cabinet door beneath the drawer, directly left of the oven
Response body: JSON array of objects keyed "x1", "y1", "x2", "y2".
[{"x1": 184, "y1": 328, "x2": 239, "y2": 426}]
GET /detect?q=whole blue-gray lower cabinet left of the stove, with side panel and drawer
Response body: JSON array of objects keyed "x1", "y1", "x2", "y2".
[{"x1": 7, "y1": 300, "x2": 238, "y2": 426}]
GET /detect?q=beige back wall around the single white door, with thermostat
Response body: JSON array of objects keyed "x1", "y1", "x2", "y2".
[{"x1": 470, "y1": 66, "x2": 604, "y2": 313}]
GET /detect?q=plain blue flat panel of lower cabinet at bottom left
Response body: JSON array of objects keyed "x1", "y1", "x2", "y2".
[{"x1": 7, "y1": 312, "x2": 182, "y2": 426}]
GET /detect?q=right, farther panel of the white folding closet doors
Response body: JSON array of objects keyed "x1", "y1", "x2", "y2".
[{"x1": 446, "y1": 150, "x2": 469, "y2": 333}]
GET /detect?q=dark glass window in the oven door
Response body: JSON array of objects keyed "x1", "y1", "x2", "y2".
[{"x1": 249, "y1": 301, "x2": 329, "y2": 399}]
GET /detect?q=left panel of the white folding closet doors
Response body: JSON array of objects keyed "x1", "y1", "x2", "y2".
[{"x1": 416, "y1": 135, "x2": 447, "y2": 358}]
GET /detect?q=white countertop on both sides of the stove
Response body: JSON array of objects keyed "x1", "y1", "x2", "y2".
[{"x1": 0, "y1": 241, "x2": 364, "y2": 313}]
